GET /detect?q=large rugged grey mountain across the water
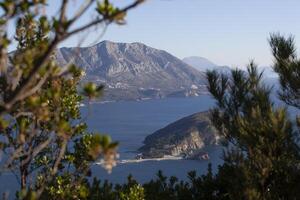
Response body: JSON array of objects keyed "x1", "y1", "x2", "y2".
[{"x1": 56, "y1": 41, "x2": 206, "y2": 100}]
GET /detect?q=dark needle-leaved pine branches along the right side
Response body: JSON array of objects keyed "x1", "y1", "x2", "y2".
[{"x1": 207, "y1": 35, "x2": 300, "y2": 199}]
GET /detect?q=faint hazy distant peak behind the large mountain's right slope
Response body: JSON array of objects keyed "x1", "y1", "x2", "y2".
[{"x1": 182, "y1": 56, "x2": 231, "y2": 74}]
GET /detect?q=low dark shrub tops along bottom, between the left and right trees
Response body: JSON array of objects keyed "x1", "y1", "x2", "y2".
[{"x1": 83, "y1": 166, "x2": 221, "y2": 200}]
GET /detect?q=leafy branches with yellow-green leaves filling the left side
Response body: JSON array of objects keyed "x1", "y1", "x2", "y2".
[{"x1": 0, "y1": 0, "x2": 142, "y2": 199}]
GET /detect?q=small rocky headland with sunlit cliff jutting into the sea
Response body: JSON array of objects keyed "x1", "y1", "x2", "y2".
[{"x1": 139, "y1": 112, "x2": 219, "y2": 158}]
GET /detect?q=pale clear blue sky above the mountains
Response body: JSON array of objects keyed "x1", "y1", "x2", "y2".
[{"x1": 7, "y1": 0, "x2": 300, "y2": 67}]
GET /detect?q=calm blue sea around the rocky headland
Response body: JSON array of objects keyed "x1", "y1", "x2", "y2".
[{"x1": 0, "y1": 96, "x2": 221, "y2": 195}]
